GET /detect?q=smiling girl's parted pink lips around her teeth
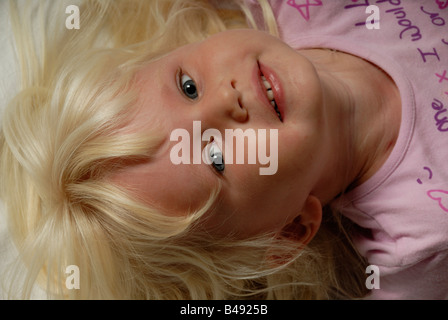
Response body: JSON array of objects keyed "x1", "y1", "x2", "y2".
[{"x1": 255, "y1": 61, "x2": 285, "y2": 121}]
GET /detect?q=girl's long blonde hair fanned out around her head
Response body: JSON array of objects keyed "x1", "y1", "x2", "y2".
[{"x1": 0, "y1": 0, "x2": 365, "y2": 299}]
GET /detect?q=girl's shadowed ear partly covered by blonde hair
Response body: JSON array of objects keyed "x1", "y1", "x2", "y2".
[{"x1": 280, "y1": 195, "x2": 322, "y2": 245}]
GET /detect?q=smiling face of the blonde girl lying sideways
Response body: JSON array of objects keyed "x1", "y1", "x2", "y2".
[{"x1": 114, "y1": 30, "x2": 326, "y2": 237}]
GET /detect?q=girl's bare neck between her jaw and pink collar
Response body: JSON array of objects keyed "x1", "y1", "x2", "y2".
[{"x1": 304, "y1": 50, "x2": 401, "y2": 204}]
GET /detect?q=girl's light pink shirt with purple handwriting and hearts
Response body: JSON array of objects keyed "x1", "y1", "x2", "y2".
[{"x1": 246, "y1": 0, "x2": 448, "y2": 299}]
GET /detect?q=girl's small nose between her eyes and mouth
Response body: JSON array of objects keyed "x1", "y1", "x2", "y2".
[{"x1": 201, "y1": 80, "x2": 248, "y2": 123}]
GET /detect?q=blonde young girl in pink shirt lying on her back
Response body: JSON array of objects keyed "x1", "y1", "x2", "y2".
[{"x1": 0, "y1": 1, "x2": 448, "y2": 299}]
